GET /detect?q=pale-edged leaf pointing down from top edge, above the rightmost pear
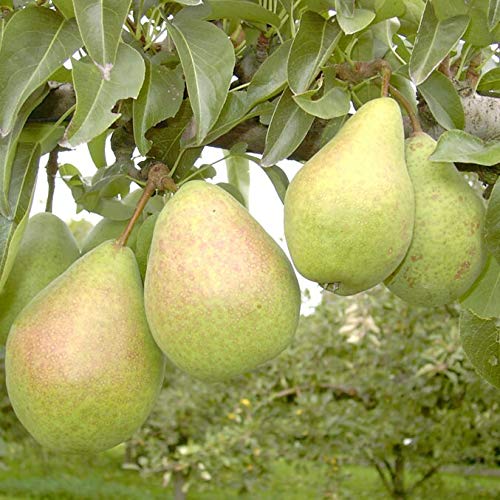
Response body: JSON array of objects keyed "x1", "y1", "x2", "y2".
[{"x1": 410, "y1": 2, "x2": 469, "y2": 85}]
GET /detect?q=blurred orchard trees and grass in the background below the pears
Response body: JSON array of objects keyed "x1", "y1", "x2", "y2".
[{"x1": 0, "y1": 287, "x2": 500, "y2": 500}]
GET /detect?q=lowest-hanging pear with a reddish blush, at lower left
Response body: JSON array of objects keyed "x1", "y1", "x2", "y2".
[{"x1": 5, "y1": 241, "x2": 165, "y2": 453}]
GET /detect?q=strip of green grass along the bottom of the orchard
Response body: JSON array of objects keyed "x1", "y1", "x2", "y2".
[{"x1": 0, "y1": 445, "x2": 500, "y2": 500}]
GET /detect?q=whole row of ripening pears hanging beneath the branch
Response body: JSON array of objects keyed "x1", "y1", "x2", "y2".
[{"x1": 0, "y1": 98, "x2": 485, "y2": 453}]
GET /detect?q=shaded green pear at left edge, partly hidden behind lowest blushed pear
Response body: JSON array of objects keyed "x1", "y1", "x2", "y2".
[{"x1": 0, "y1": 213, "x2": 80, "y2": 345}]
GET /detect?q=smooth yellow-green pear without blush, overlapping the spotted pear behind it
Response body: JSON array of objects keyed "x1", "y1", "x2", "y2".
[{"x1": 285, "y1": 97, "x2": 415, "y2": 295}]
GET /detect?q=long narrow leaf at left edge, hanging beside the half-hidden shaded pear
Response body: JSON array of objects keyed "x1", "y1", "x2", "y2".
[{"x1": 0, "y1": 143, "x2": 40, "y2": 290}]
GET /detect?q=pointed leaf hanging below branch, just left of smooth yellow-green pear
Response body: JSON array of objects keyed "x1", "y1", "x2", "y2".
[{"x1": 261, "y1": 89, "x2": 314, "y2": 167}]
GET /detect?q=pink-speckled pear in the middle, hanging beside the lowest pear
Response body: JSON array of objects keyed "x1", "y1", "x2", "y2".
[{"x1": 144, "y1": 180, "x2": 300, "y2": 381}]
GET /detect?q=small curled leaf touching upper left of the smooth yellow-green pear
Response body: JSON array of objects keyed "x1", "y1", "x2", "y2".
[{"x1": 293, "y1": 87, "x2": 351, "y2": 120}]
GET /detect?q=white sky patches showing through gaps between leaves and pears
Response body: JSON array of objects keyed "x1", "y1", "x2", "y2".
[{"x1": 31, "y1": 146, "x2": 321, "y2": 315}]
